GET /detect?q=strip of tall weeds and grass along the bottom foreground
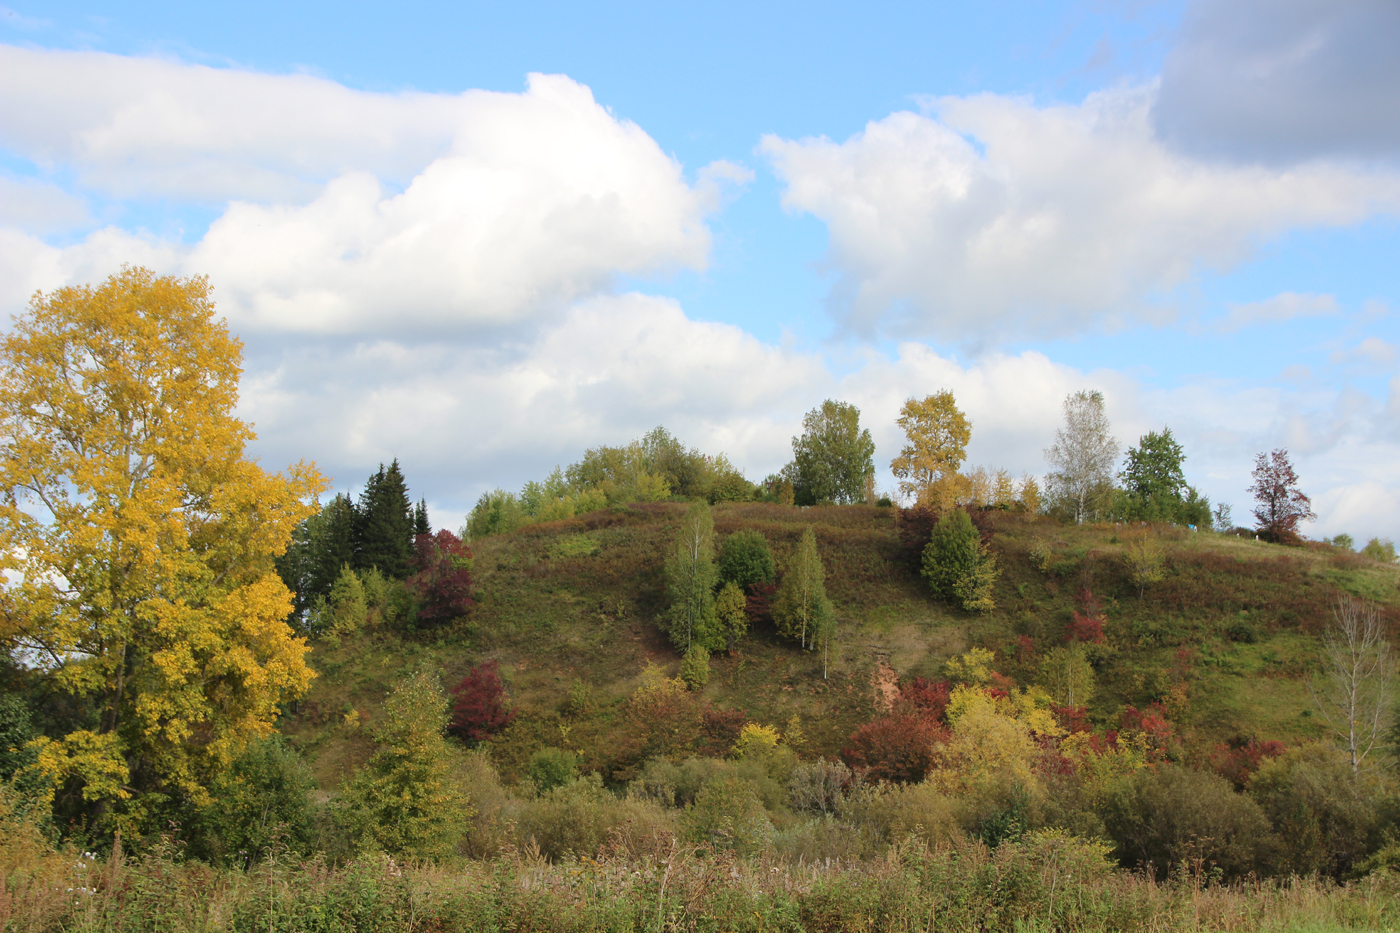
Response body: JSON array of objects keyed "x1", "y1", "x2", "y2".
[{"x1": 0, "y1": 832, "x2": 1400, "y2": 933}]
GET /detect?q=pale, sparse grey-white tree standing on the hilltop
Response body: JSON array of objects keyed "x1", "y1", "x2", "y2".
[{"x1": 1046, "y1": 389, "x2": 1119, "y2": 524}]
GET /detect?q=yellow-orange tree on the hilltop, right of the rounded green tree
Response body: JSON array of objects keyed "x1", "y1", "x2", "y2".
[{"x1": 889, "y1": 389, "x2": 972, "y2": 509}]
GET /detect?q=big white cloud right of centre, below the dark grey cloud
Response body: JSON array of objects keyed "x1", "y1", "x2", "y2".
[{"x1": 762, "y1": 87, "x2": 1400, "y2": 345}]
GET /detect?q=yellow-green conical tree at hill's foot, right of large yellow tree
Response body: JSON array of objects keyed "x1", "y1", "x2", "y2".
[{"x1": 342, "y1": 670, "x2": 472, "y2": 859}]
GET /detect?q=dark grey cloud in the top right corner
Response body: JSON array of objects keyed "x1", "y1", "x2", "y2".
[{"x1": 1152, "y1": 0, "x2": 1400, "y2": 164}]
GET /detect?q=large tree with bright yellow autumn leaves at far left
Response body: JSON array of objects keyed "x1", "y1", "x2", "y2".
[{"x1": 0, "y1": 268, "x2": 325, "y2": 829}]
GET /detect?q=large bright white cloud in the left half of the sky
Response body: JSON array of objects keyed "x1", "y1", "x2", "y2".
[{"x1": 0, "y1": 46, "x2": 752, "y2": 335}]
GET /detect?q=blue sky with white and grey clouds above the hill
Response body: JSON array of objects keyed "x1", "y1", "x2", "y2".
[{"x1": 0, "y1": 0, "x2": 1400, "y2": 542}]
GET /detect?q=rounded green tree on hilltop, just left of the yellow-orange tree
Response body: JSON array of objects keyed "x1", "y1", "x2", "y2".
[{"x1": 790, "y1": 399, "x2": 875, "y2": 506}]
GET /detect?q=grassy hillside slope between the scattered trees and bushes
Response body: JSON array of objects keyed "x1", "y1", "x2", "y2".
[{"x1": 284, "y1": 503, "x2": 1400, "y2": 790}]
